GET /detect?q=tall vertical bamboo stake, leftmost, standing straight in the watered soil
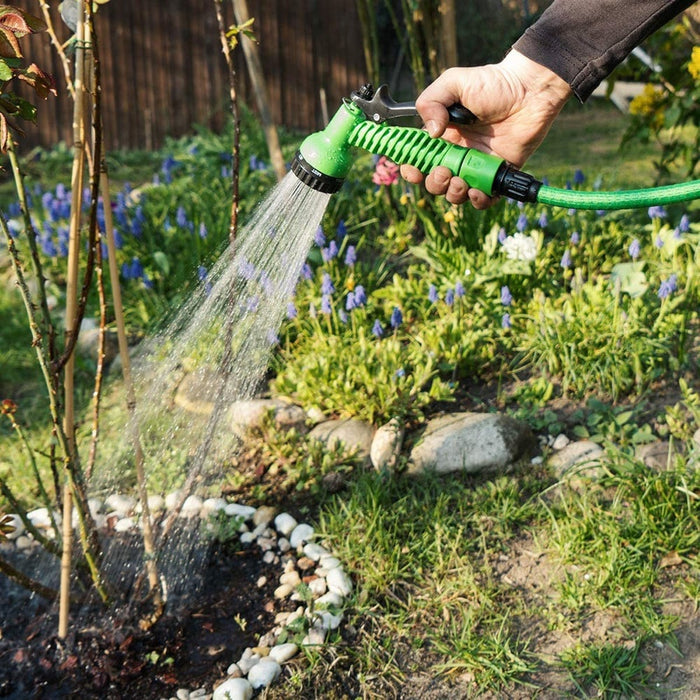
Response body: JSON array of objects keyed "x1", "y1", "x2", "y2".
[{"x1": 58, "y1": 3, "x2": 85, "y2": 639}]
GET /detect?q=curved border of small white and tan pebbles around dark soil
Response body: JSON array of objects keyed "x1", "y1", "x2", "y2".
[{"x1": 4, "y1": 493, "x2": 353, "y2": 700}]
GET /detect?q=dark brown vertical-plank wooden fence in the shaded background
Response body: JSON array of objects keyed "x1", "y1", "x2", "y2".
[{"x1": 8, "y1": 0, "x2": 365, "y2": 151}]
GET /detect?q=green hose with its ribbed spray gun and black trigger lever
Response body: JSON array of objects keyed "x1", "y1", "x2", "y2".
[{"x1": 291, "y1": 84, "x2": 700, "y2": 210}]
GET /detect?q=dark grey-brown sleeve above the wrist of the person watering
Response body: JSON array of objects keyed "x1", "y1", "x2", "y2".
[{"x1": 513, "y1": 0, "x2": 693, "y2": 102}]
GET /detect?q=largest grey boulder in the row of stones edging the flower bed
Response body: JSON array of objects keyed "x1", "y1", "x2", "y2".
[{"x1": 408, "y1": 413, "x2": 533, "y2": 474}]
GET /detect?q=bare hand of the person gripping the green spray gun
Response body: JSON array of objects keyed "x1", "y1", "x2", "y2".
[{"x1": 401, "y1": 50, "x2": 572, "y2": 209}]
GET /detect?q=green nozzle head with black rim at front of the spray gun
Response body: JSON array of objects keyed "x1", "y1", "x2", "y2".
[{"x1": 291, "y1": 100, "x2": 366, "y2": 193}]
